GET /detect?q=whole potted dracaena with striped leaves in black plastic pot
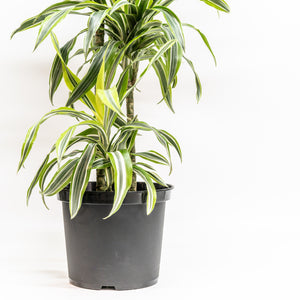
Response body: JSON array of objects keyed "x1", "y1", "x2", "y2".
[{"x1": 13, "y1": 0, "x2": 229, "y2": 290}]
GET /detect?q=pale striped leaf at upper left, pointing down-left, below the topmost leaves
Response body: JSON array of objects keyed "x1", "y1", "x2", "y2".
[{"x1": 34, "y1": 8, "x2": 71, "y2": 50}]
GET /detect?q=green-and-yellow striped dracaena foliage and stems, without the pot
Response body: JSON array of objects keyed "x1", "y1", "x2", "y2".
[{"x1": 13, "y1": 0, "x2": 229, "y2": 218}]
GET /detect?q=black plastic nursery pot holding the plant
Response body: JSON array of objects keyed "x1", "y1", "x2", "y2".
[{"x1": 58, "y1": 182, "x2": 173, "y2": 290}]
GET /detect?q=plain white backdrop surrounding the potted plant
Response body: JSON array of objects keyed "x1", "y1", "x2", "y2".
[{"x1": 0, "y1": 0, "x2": 300, "y2": 300}]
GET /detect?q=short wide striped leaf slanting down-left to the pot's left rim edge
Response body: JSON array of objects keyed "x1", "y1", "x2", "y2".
[{"x1": 43, "y1": 158, "x2": 78, "y2": 196}]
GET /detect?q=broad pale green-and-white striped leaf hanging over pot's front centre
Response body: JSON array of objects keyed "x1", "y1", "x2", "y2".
[{"x1": 105, "y1": 150, "x2": 132, "y2": 219}]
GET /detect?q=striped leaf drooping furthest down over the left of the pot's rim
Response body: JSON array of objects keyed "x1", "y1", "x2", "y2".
[{"x1": 69, "y1": 144, "x2": 96, "y2": 219}]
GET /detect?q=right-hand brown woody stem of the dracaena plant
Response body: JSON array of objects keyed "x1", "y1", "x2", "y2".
[{"x1": 126, "y1": 63, "x2": 139, "y2": 191}]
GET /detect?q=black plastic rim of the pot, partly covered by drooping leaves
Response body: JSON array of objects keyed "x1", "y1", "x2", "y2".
[{"x1": 58, "y1": 181, "x2": 174, "y2": 205}]
